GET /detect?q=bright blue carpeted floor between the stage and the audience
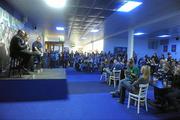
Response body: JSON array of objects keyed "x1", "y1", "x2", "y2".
[{"x1": 0, "y1": 69, "x2": 178, "y2": 120}]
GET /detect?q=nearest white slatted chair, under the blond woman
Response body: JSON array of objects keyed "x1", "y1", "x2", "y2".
[{"x1": 127, "y1": 84, "x2": 149, "y2": 114}]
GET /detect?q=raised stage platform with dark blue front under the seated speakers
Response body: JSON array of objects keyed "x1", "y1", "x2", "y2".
[{"x1": 0, "y1": 68, "x2": 68, "y2": 102}]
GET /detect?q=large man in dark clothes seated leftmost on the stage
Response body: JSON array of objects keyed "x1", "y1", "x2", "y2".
[{"x1": 10, "y1": 30, "x2": 33, "y2": 72}]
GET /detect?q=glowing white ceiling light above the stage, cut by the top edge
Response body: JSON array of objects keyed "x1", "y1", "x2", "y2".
[{"x1": 44, "y1": 0, "x2": 67, "y2": 8}]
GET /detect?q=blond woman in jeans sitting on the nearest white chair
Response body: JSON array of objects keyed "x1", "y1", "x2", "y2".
[{"x1": 119, "y1": 65, "x2": 150, "y2": 104}]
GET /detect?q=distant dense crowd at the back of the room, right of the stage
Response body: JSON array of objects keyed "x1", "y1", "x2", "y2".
[{"x1": 67, "y1": 52, "x2": 126, "y2": 72}]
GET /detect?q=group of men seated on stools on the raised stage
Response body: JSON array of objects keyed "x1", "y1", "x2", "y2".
[{"x1": 10, "y1": 30, "x2": 43, "y2": 73}]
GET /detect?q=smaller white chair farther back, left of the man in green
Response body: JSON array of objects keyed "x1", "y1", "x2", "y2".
[{"x1": 109, "y1": 70, "x2": 121, "y2": 88}]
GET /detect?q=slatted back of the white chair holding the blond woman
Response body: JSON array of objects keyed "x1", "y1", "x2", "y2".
[{"x1": 139, "y1": 83, "x2": 149, "y2": 98}]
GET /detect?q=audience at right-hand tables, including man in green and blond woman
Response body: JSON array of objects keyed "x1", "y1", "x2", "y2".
[{"x1": 105, "y1": 53, "x2": 180, "y2": 110}]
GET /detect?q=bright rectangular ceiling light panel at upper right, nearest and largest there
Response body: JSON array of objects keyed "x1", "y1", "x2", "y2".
[{"x1": 117, "y1": 1, "x2": 142, "y2": 12}]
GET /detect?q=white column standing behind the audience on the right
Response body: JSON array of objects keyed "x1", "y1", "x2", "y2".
[{"x1": 127, "y1": 29, "x2": 134, "y2": 59}]
